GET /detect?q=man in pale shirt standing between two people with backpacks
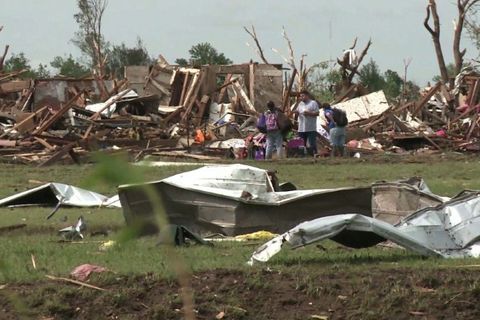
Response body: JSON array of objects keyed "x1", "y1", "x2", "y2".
[{"x1": 295, "y1": 90, "x2": 319, "y2": 156}]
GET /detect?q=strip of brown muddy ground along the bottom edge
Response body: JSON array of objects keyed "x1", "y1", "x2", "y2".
[{"x1": 0, "y1": 265, "x2": 480, "y2": 319}]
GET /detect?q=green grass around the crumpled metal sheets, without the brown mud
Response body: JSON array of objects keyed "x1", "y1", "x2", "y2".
[{"x1": 0, "y1": 156, "x2": 480, "y2": 286}]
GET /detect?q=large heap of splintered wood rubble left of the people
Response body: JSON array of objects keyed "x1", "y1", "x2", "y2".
[{"x1": 0, "y1": 61, "x2": 283, "y2": 166}]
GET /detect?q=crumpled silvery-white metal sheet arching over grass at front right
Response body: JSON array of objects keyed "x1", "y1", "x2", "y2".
[{"x1": 249, "y1": 192, "x2": 480, "y2": 264}]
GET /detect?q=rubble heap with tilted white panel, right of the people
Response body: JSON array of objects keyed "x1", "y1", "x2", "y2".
[{"x1": 338, "y1": 70, "x2": 480, "y2": 153}]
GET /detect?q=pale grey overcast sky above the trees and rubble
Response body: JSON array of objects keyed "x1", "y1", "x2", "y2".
[{"x1": 0, "y1": 0, "x2": 476, "y2": 85}]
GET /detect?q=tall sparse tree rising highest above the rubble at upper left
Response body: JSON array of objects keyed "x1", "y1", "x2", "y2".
[{"x1": 72, "y1": 0, "x2": 108, "y2": 78}]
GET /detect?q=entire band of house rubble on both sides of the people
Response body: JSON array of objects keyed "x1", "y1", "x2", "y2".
[{"x1": 0, "y1": 59, "x2": 480, "y2": 166}]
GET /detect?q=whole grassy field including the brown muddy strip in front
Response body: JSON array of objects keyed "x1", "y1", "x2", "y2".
[{"x1": 0, "y1": 155, "x2": 480, "y2": 319}]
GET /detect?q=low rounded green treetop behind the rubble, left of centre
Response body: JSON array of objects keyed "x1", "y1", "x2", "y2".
[{"x1": 175, "y1": 42, "x2": 233, "y2": 67}]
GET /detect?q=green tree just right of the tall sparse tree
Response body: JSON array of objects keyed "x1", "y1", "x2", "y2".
[{"x1": 107, "y1": 38, "x2": 153, "y2": 78}]
